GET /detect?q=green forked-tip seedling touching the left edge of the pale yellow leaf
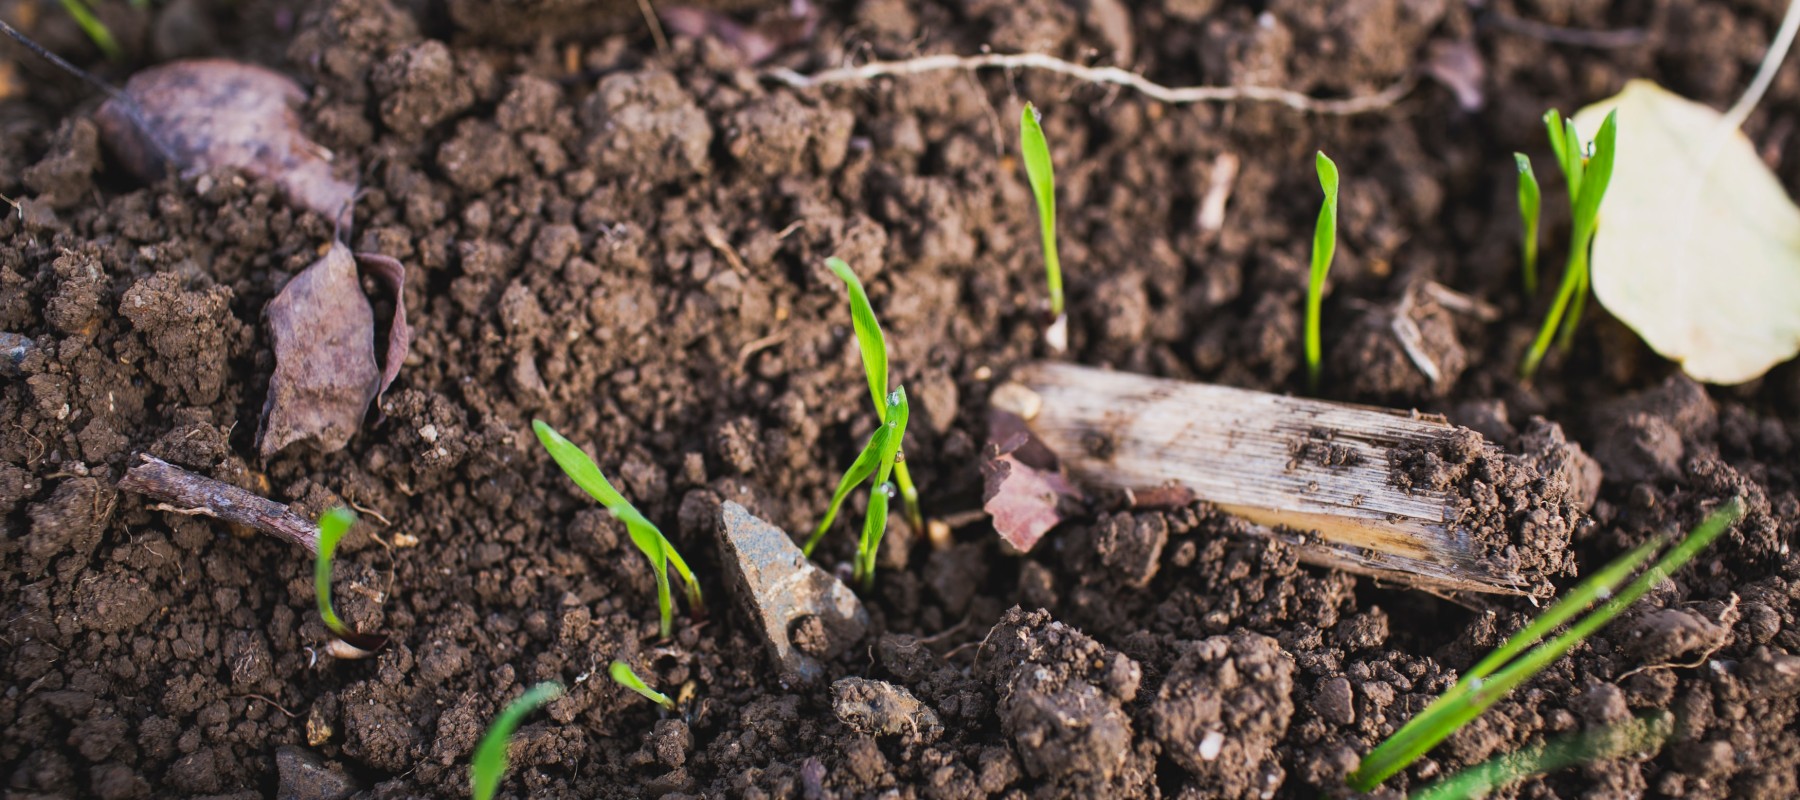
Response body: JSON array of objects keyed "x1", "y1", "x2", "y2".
[{"x1": 1519, "y1": 108, "x2": 1618, "y2": 380}]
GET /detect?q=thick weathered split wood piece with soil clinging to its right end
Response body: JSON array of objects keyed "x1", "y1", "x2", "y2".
[{"x1": 995, "y1": 362, "x2": 1582, "y2": 595}]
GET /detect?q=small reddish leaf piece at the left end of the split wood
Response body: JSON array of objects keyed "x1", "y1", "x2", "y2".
[{"x1": 981, "y1": 411, "x2": 1082, "y2": 551}]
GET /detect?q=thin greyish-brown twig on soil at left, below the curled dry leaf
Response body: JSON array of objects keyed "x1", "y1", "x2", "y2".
[{"x1": 119, "y1": 454, "x2": 319, "y2": 555}]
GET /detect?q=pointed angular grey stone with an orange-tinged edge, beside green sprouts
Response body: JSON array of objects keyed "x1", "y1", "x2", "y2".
[{"x1": 718, "y1": 501, "x2": 869, "y2": 685}]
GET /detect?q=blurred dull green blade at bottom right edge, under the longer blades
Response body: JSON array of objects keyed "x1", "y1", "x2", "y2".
[{"x1": 1411, "y1": 712, "x2": 1674, "y2": 800}]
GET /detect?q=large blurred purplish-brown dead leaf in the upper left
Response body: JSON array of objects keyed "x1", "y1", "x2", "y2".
[{"x1": 95, "y1": 59, "x2": 355, "y2": 223}]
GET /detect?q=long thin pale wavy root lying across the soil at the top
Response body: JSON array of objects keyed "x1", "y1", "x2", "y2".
[{"x1": 767, "y1": 52, "x2": 1417, "y2": 115}]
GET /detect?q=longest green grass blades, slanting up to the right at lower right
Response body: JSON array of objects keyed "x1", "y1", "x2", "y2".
[{"x1": 1348, "y1": 499, "x2": 1744, "y2": 791}]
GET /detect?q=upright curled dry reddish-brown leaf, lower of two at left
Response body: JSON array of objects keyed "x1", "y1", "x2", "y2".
[{"x1": 259, "y1": 241, "x2": 379, "y2": 458}]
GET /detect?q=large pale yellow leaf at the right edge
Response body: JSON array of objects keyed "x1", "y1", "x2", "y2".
[{"x1": 1575, "y1": 81, "x2": 1800, "y2": 384}]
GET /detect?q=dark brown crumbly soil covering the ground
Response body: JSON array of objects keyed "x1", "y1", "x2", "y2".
[{"x1": 0, "y1": 0, "x2": 1800, "y2": 798}]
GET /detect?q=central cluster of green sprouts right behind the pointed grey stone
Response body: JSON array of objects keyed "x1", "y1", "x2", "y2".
[{"x1": 805, "y1": 258, "x2": 925, "y2": 587}]
